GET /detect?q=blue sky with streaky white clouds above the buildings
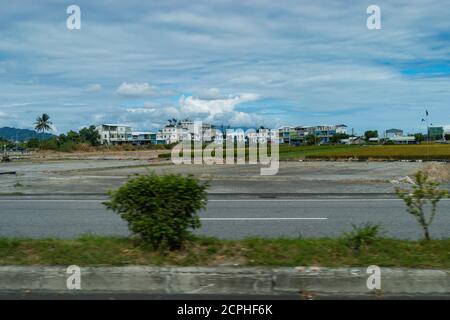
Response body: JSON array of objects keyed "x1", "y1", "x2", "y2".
[{"x1": 0, "y1": 0, "x2": 450, "y2": 133}]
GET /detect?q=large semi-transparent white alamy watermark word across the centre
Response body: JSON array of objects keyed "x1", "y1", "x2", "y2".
[{"x1": 171, "y1": 122, "x2": 280, "y2": 176}]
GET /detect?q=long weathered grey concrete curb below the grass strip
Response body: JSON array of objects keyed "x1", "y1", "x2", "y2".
[{"x1": 0, "y1": 266, "x2": 450, "y2": 295}]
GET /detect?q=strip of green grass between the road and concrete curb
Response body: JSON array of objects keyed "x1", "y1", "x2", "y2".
[{"x1": 0, "y1": 236, "x2": 450, "y2": 269}]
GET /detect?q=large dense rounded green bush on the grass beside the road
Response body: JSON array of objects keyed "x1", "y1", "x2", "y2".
[{"x1": 105, "y1": 174, "x2": 208, "y2": 249}]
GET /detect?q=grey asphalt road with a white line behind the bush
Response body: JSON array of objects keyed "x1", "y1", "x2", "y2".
[{"x1": 0, "y1": 196, "x2": 450, "y2": 239}]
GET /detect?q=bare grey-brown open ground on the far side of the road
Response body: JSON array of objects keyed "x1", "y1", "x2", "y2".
[{"x1": 0, "y1": 158, "x2": 442, "y2": 194}]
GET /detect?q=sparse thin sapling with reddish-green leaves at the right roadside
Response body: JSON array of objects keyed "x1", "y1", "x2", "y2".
[{"x1": 395, "y1": 171, "x2": 448, "y2": 240}]
